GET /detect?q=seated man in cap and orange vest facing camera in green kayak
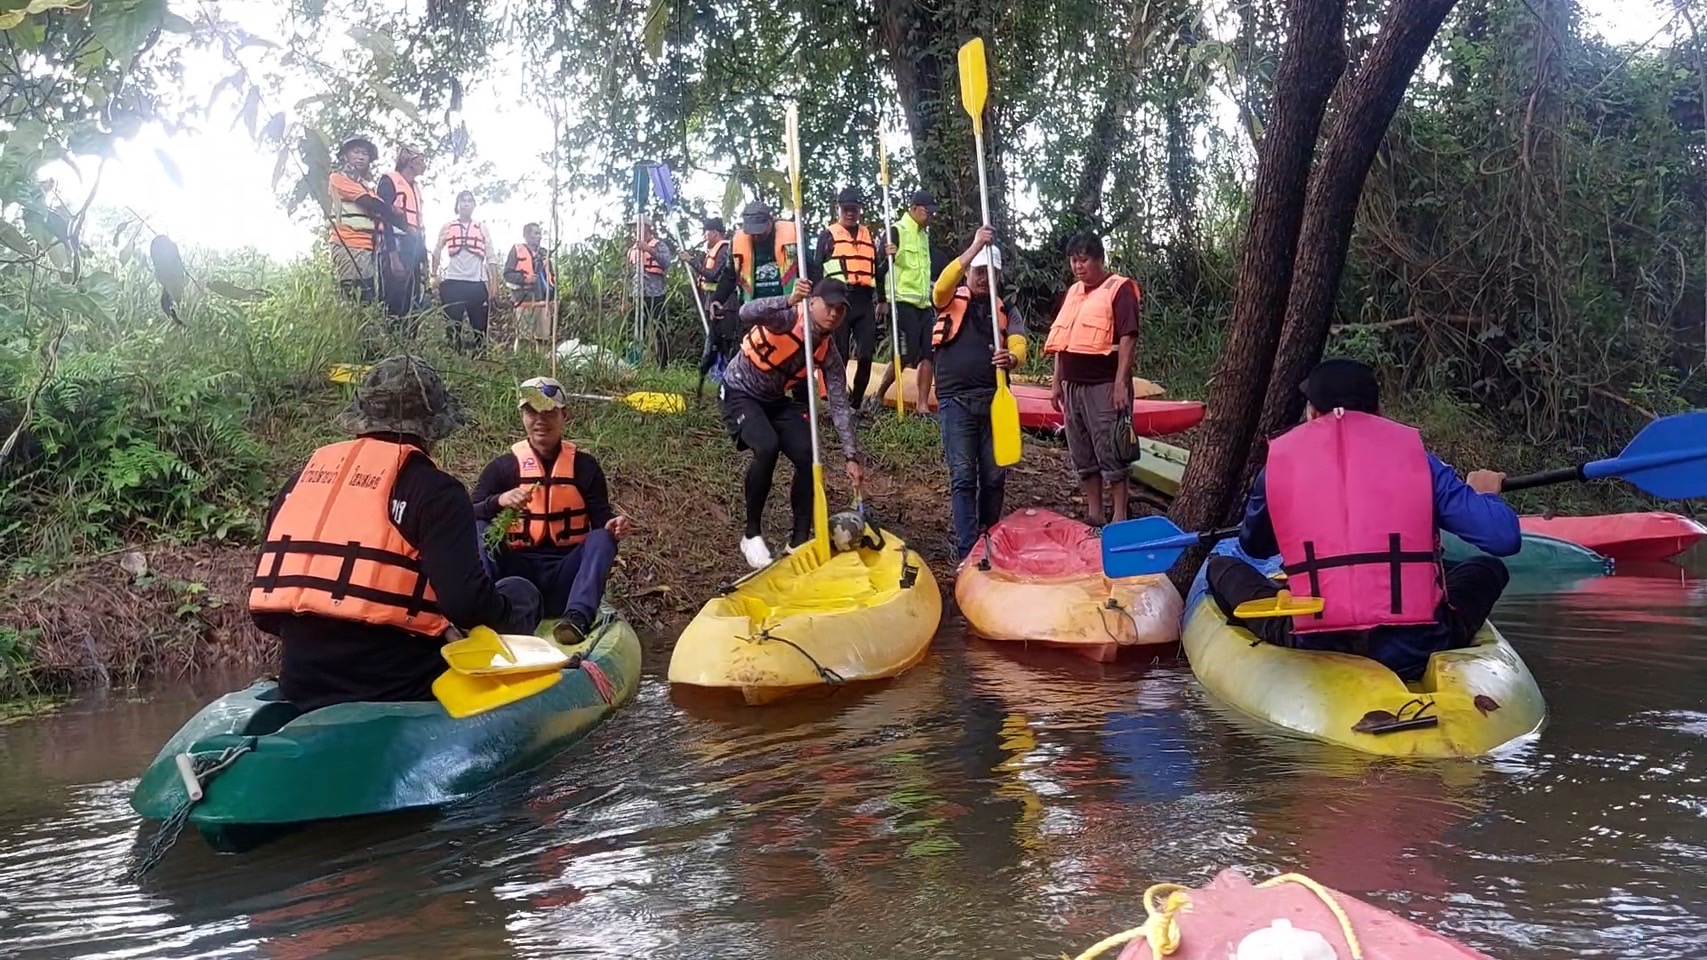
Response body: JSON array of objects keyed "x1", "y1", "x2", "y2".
[{"x1": 475, "y1": 378, "x2": 630, "y2": 646}]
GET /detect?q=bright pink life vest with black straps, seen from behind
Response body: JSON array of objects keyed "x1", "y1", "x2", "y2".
[{"x1": 1263, "y1": 410, "x2": 1444, "y2": 634}]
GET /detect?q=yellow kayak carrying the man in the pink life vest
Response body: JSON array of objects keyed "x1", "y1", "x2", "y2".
[{"x1": 1180, "y1": 598, "x2": 1547, "y2": 757}]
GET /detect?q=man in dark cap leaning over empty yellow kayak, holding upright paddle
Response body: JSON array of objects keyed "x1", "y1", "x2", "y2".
[{"x1": 719, "y1": 277, "x2": 864, "y2": 571}]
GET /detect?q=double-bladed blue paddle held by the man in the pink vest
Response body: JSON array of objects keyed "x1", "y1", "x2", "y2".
[{"x1": 1103, "y1": 410, "x2": 1707, "y2": 577}]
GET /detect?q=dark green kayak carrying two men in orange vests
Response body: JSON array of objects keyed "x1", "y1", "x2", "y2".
[{"x1": 130, "y1": 608, "x2": 640, "y2": 851}]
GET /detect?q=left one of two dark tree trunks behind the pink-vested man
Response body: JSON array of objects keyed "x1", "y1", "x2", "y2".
[{"x1": 1169, "y1": 0, "x2": 1345, "y2": 593}]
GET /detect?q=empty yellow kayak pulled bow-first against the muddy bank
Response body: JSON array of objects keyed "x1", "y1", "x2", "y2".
[{"x1": 669, "y1": 531, "x2": 942, "y2": 704}]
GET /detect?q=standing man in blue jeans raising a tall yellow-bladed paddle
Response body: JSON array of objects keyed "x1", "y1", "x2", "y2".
[{"x1": 918, "y1": 227, "x2": 1026, "y2": 559}]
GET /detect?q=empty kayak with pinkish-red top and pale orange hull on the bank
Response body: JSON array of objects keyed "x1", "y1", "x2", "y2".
[{"x1": 954, "y1": 509, "x2": 1183, "y2": 663}]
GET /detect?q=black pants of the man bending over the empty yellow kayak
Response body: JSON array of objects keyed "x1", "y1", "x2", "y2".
[{"x1": 722, "y1": 386, "x2": 813, "y2": 545}]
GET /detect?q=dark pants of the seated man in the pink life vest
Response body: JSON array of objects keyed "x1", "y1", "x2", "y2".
[{"x1": 1207, "y1": 555, "x2": 1511, "y2": 682}]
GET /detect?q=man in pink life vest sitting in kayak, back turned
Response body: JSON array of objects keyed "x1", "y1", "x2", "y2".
[{"x1": 1207, "y1": 359, "x2": 1523, "y2": 680}]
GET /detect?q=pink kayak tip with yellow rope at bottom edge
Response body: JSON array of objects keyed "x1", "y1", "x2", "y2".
[{"x1": 1104, "y1": 869, "x2": 1489, "y2": 960}]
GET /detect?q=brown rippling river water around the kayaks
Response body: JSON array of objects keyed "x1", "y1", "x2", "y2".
[{"x1": 0, "y1": 560, "x2": 1707, "y2": 960}]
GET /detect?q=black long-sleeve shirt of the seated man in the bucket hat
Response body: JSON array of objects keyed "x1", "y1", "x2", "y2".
[{"x1": 251, "y1": 436, "x2": 514, "y2": 711}]
